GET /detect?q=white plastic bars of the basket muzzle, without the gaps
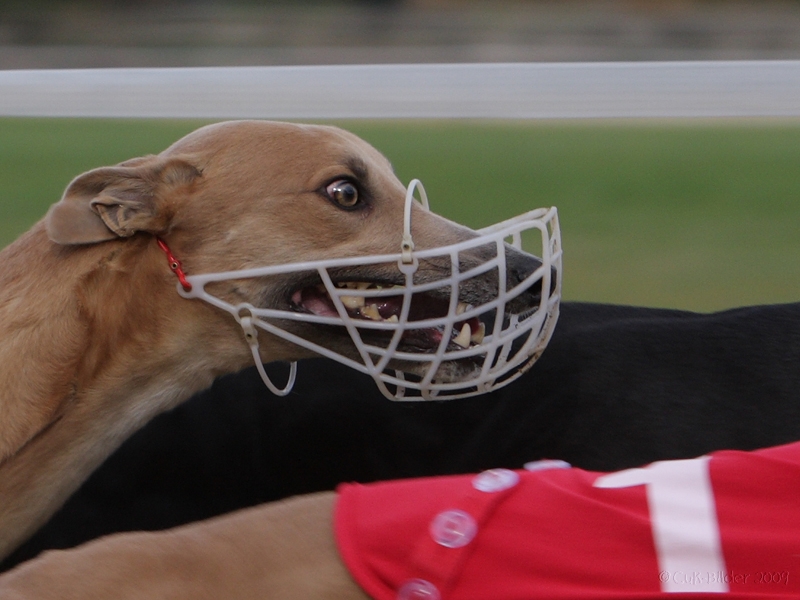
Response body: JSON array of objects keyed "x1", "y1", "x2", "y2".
[{"x1": 178, "y1": 179, "x2": 562, "y2": 400}]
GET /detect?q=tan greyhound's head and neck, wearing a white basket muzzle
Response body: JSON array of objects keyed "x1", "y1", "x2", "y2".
[{"x1": 0, "y1": 121, "x2": 557, "y2": 556}]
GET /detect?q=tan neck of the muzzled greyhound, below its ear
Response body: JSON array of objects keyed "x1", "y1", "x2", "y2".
[{"x1": 0, "y1": 224, "x2": 247, "y2": 557}]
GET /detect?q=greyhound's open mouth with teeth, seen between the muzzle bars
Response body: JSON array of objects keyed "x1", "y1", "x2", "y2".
[{"x1": 291, "y1": 281, "x2": 486, "y2": 352}]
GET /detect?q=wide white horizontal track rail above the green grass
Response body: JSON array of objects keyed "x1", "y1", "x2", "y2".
[{"x1": 0, "y1": 61, "x2": 800, "y2": 119}]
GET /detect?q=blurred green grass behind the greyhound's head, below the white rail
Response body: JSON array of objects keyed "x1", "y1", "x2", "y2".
[{"x1": 0, "y1": 119, "x2": 800, "y2": 310}]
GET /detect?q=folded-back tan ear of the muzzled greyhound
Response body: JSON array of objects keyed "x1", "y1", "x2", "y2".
[{"x1": 45, "y1": 156, "x2": 200, "y2": 244}]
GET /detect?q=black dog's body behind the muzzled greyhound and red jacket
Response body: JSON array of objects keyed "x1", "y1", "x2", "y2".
[{"x1": 3, "y1": 303, "x2": 800, "y2": 568}]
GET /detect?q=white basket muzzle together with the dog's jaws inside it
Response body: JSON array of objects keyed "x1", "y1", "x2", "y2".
[{"x1": 178, "y1": 180, "x2": 561, "y2": 400}]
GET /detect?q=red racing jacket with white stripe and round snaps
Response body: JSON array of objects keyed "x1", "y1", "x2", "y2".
[{"x1": 335, "y1": 443, "x2": 800, "y2": 600}]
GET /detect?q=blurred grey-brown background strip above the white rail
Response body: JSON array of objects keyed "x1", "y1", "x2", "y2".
[{"x1": 0, "y1": 0, "x2": 800, "y2": 69}]
